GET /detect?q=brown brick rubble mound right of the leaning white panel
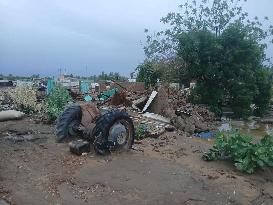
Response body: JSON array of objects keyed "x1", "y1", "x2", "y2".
[{"x1": 129, "y1": 86, "x2": 217, "y2": 135}]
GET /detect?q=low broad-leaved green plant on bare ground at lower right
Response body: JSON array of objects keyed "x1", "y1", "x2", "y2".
[{"x1": 202, "y1": 131, "x2": 273, "y2": 174}]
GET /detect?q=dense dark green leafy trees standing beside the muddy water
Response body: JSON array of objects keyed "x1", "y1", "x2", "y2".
[{"x1": 178, "y1": 22, "x2": 271, "y2": 117}]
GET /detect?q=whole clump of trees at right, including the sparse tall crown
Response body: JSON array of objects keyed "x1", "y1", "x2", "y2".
[{"x1": 137, "y1": 0, "x2": 273, "y2": 118}]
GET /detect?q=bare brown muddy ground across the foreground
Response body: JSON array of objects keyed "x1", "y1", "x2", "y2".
[{"x1": 0, "y1": 118, "x2": 273, "y2": 205}]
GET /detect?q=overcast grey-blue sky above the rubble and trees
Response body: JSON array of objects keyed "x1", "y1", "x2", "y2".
[{"x1": 0, "y1": 0, "x2": 273, "y2": 76}]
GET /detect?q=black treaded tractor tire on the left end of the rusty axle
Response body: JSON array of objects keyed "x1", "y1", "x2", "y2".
[{"x1": 56, "y1": 105, "x2": 82, "y2": 142}]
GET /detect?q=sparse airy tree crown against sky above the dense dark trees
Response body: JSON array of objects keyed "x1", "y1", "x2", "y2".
[{"x1": 144, "y1": 0, "x2": 273, "y2": 60}]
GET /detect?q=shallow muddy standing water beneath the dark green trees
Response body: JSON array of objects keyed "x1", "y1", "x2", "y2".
[{"x1": 219, "y1": 119, "x2": 273, "y2": 138}]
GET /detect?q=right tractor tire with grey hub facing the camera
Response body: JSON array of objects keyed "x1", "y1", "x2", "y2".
[{"x1": 93, "y1": 110, "x2": 135, "y2": 155}]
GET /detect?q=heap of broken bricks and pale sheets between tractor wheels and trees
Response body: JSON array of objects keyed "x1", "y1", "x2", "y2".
[{"x1": 97, "y1": 86, "x2": 218, "y2": 138}]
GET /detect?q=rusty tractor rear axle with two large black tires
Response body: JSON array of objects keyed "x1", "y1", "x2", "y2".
[{"x1": 56, "y1": 103, "x2": 135, "y2": 154}]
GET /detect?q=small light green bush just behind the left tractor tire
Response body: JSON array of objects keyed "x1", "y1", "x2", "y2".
[{"x1": 45, "y1": 85, "x2": 72, "y2": 120}]
